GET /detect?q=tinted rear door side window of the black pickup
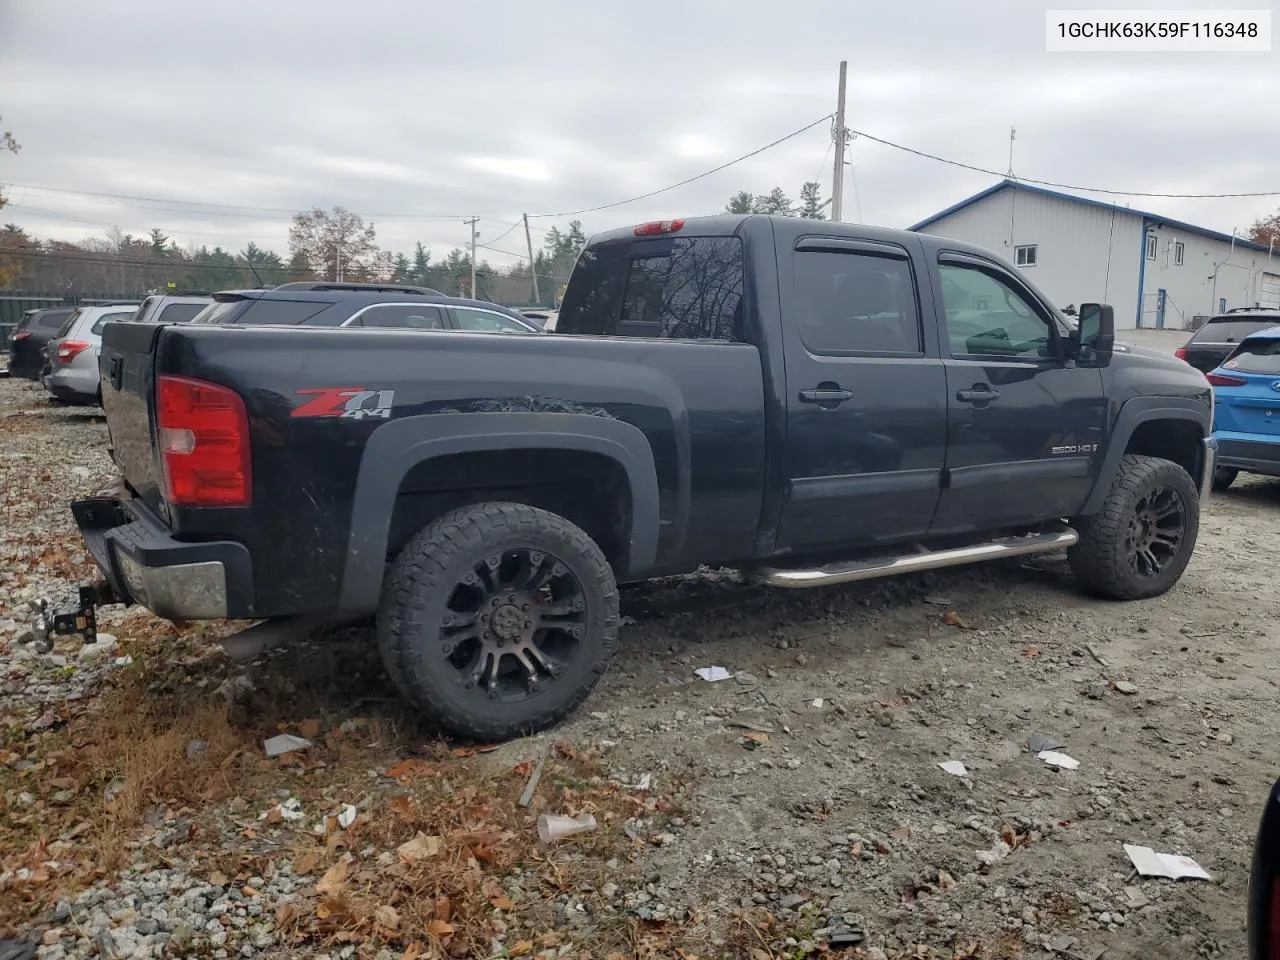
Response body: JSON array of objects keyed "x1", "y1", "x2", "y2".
[{"x1": 795, "y1": 251, "x2": 920, "y2": 355}]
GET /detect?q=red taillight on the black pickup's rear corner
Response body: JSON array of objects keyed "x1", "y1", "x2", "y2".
[{"x1": 156, "y1": 375, "x2": 252, "y2": 507}]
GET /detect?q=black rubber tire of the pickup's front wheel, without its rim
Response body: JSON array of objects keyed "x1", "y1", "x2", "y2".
[{"x1": 1066, "y1": 453, "x2": 1199, "y2": 600}]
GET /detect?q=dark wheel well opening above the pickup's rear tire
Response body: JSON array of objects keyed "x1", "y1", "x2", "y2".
[{"x1": 387, "y1": 449, "x2": 631, "y2": 573}]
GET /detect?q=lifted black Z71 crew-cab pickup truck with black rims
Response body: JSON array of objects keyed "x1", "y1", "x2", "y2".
[{"x1": 64, "y1": 216, "x2": 1213, "y2": 737}]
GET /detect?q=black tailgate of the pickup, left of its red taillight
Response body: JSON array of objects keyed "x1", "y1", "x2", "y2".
[{"x1": 99, "y1": 323, "x2": 164, "y2": 511}]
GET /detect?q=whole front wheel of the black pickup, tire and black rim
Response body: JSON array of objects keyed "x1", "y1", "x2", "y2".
[{"x1": 1068, "y1": 454, "x2": 1199, "y2": 600}]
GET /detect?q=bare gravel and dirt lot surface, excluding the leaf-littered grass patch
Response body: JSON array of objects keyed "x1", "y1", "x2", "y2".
[{"x1": 0, "y1": 371, "x2": 1280, "y2": 960}]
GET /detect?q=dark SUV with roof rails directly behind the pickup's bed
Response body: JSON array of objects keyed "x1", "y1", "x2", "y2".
[{"x1": 192, "y1": 283, "x2": 541, "y2": 333}]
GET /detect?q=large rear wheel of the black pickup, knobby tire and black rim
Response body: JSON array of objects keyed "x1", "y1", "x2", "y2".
[{"x1": 378, "y1": 503, "x2": 618, "y2": 741}]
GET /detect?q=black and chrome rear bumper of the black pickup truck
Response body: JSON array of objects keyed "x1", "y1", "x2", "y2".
[{"x1": 72, "y1": 497, "x2": 253, "y2": 620}]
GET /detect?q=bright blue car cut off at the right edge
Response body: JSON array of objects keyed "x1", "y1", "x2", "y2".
[{"x1": 1206, "y1": 326, "x2": 1280, "y2": 490}]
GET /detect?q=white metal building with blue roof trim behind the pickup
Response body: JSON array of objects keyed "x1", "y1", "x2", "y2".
[{"x1": 909, "y1": 180, "x2": 1280, "y2": 329}]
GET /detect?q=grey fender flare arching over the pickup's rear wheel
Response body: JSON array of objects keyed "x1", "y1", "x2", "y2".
[{"x1": 338, "y1": 412, "x2": 659, "y2": 614}]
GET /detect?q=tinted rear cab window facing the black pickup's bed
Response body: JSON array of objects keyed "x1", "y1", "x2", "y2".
[{"x1": 557, "y1": 237, "x2": 744, "y2": 340}]
